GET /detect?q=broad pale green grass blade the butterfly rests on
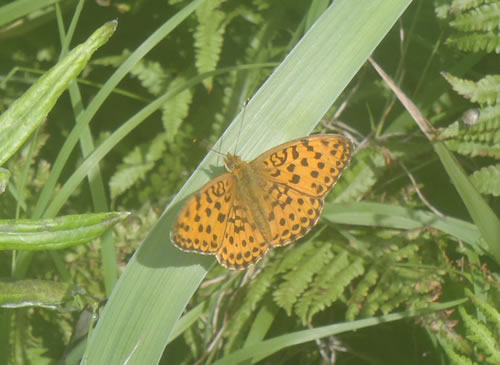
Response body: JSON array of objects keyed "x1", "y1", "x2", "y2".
[{"x1": 87, "y1": 0, "x2": 410, "y2": 365}]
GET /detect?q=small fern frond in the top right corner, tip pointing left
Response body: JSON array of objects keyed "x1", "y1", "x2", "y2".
[{"x1": 450, "y1": 3, "x2": 500, "y2": 31}]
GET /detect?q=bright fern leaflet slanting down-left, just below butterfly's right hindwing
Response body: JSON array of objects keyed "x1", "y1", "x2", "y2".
[{"x1": 273, "y1": 242, "x2": 333, "y2": 315}]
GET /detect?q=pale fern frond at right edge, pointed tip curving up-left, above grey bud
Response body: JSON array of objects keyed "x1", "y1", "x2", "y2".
[{"x1": 442, "y1": 72, "x2": 500, "y2": 105}]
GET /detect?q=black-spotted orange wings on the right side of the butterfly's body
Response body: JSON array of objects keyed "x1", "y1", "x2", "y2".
[{"x1": 251, "y1": 134, "x2": 352, "y2": 246}]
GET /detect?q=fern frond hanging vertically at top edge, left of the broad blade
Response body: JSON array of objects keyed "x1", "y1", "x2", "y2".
[{"x1": 194, "y1": 0, "x2": 226, "y2": 90}]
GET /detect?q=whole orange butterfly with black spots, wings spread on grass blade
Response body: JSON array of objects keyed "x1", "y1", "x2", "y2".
[{"x1": 170, "y1": 134, "x2": 353, "y2": 270}]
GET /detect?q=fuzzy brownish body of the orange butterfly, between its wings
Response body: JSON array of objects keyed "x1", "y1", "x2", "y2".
[{"x1": 224, "y1": 154, "x2": 272, "y2": 243}]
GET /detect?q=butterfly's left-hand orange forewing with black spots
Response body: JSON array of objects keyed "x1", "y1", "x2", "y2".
[{"x1": 170, "y1": 173, "x2": 236, "y2": 255}]
